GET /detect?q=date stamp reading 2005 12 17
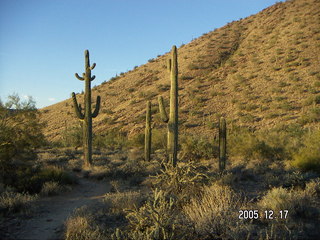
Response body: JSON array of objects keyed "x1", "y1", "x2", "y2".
[{"x1": 238, "y1": 210, "x2": 289, "y2": 220}]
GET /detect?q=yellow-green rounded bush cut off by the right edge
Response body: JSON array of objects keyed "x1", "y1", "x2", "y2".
[{"x1": 292, "y1": 130, "x2": 320, "y2": 172}]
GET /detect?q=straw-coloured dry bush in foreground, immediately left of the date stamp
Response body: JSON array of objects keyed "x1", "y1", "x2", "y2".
[{"x1": 183, "y1": 183, "x2": 244, "y2": 239}]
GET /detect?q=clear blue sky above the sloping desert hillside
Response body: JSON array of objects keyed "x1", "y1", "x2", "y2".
[{"x1": 0, "y1": 0, "x2": 282, "y2": 108}]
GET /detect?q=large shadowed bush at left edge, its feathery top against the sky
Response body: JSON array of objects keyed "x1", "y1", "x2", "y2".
[{"x1": 0, "y1": 94, "x2": 45, "y2": 178}]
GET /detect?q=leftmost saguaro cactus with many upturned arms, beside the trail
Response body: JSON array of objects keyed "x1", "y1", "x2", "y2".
[{"x1": 72, "y1": 50, "x2": 100, "y2": 166}]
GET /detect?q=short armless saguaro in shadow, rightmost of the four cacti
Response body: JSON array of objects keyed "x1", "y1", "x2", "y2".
[{"x1": 219, "y1": 117, "x2": 227, "y2": 172}]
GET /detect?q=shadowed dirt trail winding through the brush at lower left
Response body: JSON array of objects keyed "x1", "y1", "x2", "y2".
[{"x1": 12, "y1": 178, "x2": 110, "y2": 240}]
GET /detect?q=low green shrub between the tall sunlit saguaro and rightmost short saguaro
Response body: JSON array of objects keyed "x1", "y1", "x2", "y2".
[{"x1": 181, "y1": 136, "x2": 218, "y2": 160}]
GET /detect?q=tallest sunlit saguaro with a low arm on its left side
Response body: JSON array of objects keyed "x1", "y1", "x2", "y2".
[{"x1": 158, "y1": 46, "x2": 178, "y2": 167}]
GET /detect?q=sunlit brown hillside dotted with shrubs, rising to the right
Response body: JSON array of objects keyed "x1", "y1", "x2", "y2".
[{"x1": 41, "y1": 0, "x2": 320, "y2": 140}]
